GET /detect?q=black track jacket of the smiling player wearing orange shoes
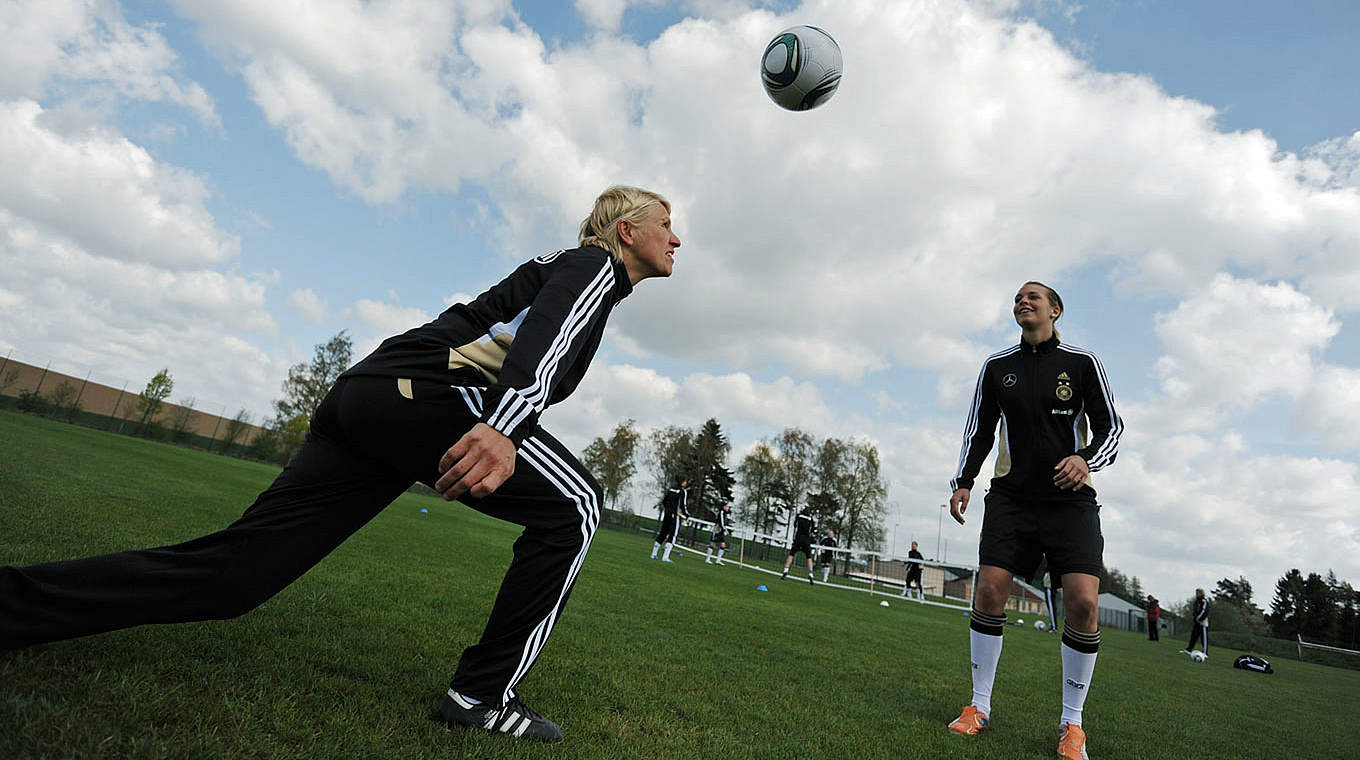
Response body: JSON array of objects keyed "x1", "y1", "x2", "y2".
[{"x1": 951, "y1": 336, "x2": 1123, "y2": 498}]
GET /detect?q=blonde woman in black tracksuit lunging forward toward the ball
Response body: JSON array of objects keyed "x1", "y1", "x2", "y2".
[{"x1": 0, "y1": 186, "x2": 680, "y2": 741}]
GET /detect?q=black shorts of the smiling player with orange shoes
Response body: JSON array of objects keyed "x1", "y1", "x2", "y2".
[{"x1": 978, "y1": 491, "x2": 1104, "y2": 582}]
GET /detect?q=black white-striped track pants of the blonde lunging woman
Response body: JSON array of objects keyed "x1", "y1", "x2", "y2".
[{"x1": 0, "y1": 378, "x2": 601, "y2": 703}]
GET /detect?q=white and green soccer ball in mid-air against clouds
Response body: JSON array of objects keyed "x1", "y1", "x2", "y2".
[{"x1": 760, "y1": 26, "x2": 840, "y2": 111}]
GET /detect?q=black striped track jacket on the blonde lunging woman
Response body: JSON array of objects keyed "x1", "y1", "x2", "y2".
[{"x1": 341, "y1": 246, "x2": 632, "y2": 446}]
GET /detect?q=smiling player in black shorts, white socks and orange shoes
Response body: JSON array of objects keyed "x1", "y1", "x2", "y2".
[{"x1": 949, "y1": 281, "x2": 1123, "y2": 760}]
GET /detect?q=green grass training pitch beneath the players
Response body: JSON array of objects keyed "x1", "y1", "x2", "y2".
[{"x1": 0, "y1": 412, "x2": 1360, "y2": 760}]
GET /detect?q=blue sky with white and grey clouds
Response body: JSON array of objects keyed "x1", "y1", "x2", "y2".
[{"x1": 0, "y1": 0, "x2": 1360, "y2": 608}]
